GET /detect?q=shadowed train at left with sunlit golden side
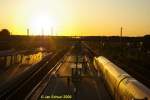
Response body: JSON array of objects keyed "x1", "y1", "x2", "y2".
[{"x1": 0, "y1": 50, "x2": 48, "y2": 68}]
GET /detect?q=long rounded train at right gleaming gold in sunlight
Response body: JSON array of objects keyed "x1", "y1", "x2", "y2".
[{"x1": 93, "y1": 56, "x2": 150, "y2": 100}]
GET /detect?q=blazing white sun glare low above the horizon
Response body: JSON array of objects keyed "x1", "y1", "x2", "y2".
[{"x1": 30, "y1": 14, "x2": 57, "y2": 35}]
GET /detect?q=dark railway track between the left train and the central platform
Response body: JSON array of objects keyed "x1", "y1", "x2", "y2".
[{"x1": 0, "y1": 50, "x2": 67, "y2": 100}]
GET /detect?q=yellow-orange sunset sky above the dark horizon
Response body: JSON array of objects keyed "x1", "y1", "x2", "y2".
[{"x1": 0, "y1": 0, "x2": 150, "y2": 36}]
